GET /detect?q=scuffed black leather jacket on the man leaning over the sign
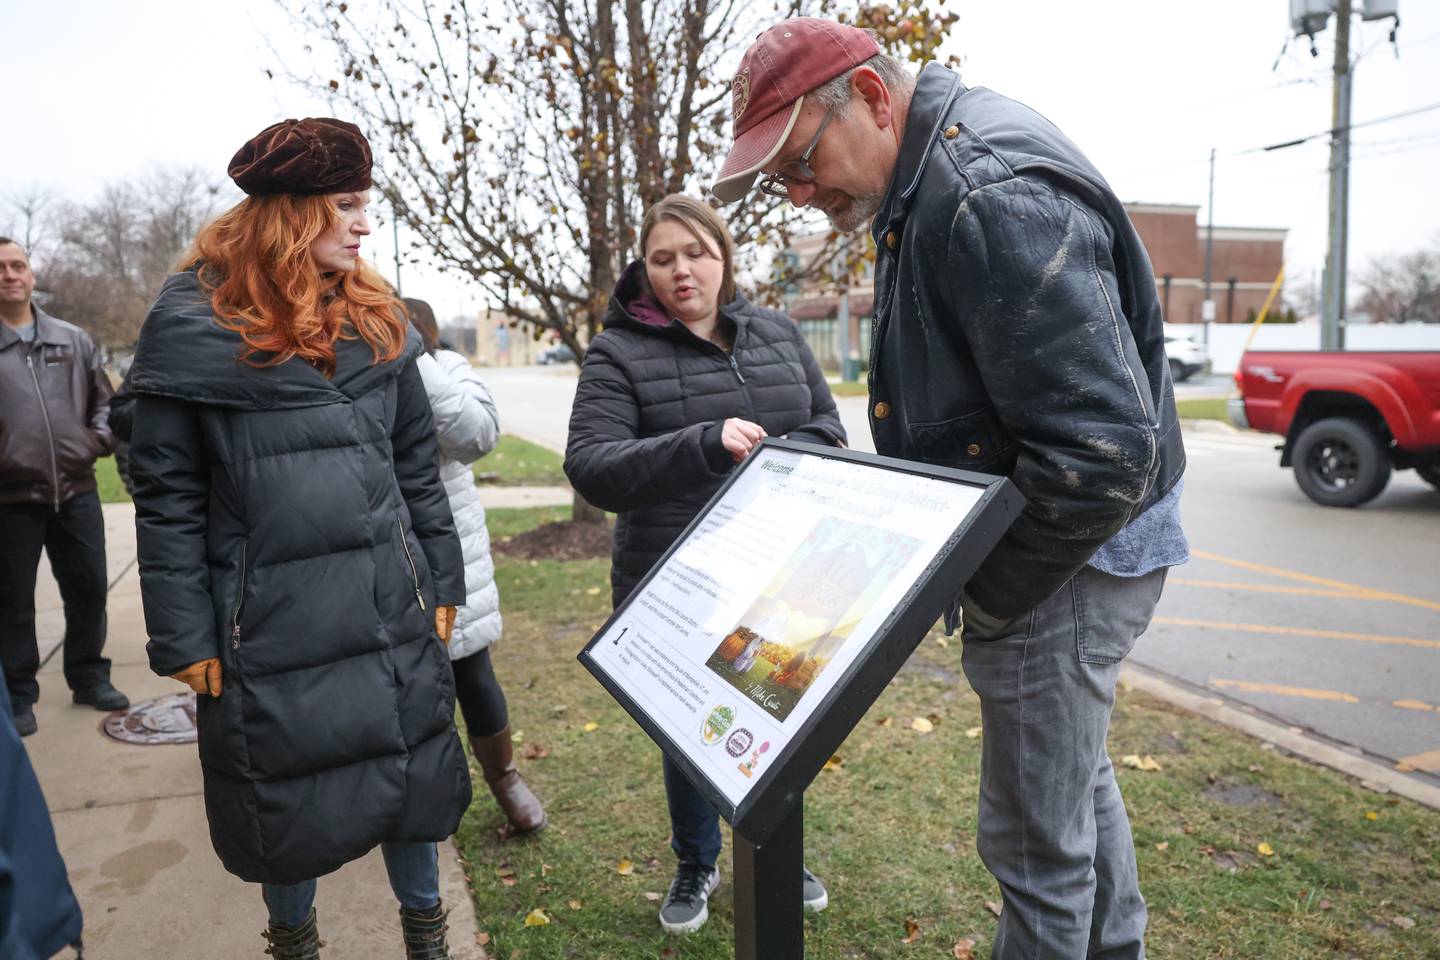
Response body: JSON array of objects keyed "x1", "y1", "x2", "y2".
[{"x1": 870, "y1": 63, "x2": 1185, "y2": 617}]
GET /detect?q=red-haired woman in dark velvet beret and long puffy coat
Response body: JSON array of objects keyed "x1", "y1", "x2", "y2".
[{"x1": 128, "y1": 119, "x2": 469, "y2": 960}]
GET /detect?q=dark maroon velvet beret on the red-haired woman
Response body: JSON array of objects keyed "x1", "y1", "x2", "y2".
[{"x1": 229, "y1": 117, "x2": 370, "y2": 197}]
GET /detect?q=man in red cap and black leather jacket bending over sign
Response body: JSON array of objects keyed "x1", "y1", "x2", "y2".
[{"x1": 713, "y1": 19, "x2": 1189, "y2": 960}]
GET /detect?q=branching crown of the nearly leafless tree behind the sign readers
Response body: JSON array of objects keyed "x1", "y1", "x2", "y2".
[{"x1": 279, "y1": 0, "x2": 958, "y2": 358}]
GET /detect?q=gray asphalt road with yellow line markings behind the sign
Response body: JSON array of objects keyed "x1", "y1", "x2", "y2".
[{"x1": 482, "y1": 367, "x2": 1440, "y2": 782}]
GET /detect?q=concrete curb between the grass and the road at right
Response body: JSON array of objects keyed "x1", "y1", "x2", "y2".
[{"x1": 1120, "y1": 664, "x2": 1440, "y2": 810}]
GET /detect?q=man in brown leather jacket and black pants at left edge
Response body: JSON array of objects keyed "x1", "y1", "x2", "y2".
[{"x1": 0, "y1": 237, "x2": 130, "y2": 735}]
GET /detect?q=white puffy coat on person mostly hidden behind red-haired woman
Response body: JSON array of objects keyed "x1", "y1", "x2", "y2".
[{"x1": 419, "y1": 350, "x2": 500, "y2": 661}]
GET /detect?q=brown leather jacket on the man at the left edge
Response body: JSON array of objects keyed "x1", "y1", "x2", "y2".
[{"x1": 0, "y1": 307, "x2": 114, "y2": 507}]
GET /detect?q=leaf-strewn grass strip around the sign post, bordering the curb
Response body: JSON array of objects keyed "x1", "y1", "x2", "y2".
[{"x1": 459, "y1": 508, "x2": 1440, "y2": 960}]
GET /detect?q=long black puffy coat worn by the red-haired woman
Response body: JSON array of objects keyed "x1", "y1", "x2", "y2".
[{"x1": 128, "y1": 273, "x2": 469, "y2": 884}]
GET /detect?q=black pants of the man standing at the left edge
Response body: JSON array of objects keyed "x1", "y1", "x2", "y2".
[{"x1": 0, "y1": 491, "x2": 109, "y2": 710}]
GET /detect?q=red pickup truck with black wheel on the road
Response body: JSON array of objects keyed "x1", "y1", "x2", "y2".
[{"x1": 1230, "y1": 350, "x2": 1440, "y2": 507}]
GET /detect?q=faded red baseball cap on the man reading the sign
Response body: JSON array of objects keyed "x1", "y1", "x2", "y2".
[{"x1": 710, "y1": 17, "x2": 880, "y2": 203}]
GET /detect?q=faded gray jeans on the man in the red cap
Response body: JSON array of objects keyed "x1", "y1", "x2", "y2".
[{"x1": 962, "y1": 567, "x2": 1166, "y2": 960}]
